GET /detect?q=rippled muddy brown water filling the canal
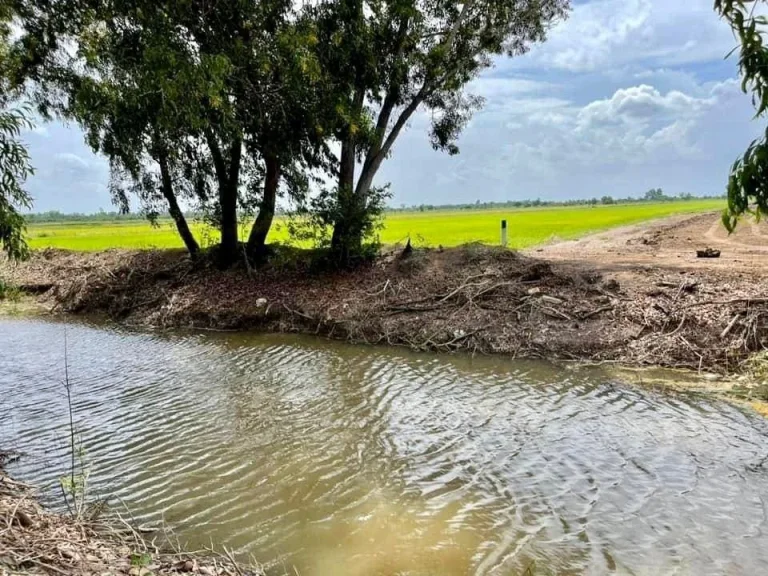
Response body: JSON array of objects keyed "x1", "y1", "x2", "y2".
[{"x1": 0, "y1": 320, "x2": 768, "y2": 576}]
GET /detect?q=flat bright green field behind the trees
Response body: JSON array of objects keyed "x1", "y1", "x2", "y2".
[{"x1": 28, "y1": 199, "x2": 725, "y2": 251}]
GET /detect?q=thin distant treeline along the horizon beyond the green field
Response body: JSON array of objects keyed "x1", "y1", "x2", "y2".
[{"x1": 26, "y1": 188, "x2": 725, "y2": 224}]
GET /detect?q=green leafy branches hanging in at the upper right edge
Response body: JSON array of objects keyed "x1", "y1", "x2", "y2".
[{"x1": 715, "y1": 0, "x2": 768, "y2": 232}]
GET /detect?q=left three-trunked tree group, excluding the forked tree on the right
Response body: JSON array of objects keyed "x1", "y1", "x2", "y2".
[{"x1": 12, "y1": 0, "x2": 326, "y2": 264}]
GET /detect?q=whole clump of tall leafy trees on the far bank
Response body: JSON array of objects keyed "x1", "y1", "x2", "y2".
[{"x1": 9, "y1": 0, "x2": 569, "y2": 264}]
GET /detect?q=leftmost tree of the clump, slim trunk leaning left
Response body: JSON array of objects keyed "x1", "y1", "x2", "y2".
[{"x1": 14, "y1": 0, "x2": 225, "y2": 257}]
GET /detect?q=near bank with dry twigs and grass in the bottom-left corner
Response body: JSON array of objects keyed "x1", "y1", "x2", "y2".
[{"x1": 0, "y1": 470, "x2": 263, "y2": 576}]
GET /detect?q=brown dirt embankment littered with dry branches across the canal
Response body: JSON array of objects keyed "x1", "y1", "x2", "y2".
[{"x1": 1, "y1": 214, "x2": 768, "y2": 373}]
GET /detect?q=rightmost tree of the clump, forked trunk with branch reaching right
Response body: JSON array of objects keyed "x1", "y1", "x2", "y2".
[{"x1": 313, "y1": 0, "x2": 569, "y2": 259}]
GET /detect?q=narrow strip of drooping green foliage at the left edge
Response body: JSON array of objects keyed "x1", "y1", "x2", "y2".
[{"x1": 0, "y1": 109, "x2": 34, "y2": 259}]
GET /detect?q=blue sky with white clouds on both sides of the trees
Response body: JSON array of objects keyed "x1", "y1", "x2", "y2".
[{"x1": 18, "y1": 0, "x2": 760, "y2": 212}]
